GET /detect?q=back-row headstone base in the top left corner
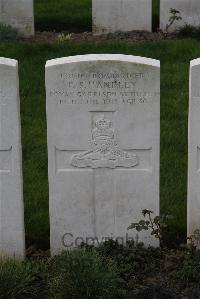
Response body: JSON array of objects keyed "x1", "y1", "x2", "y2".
[{"x1": 0, "y1": 0, "x2": 34, "y2": 37}]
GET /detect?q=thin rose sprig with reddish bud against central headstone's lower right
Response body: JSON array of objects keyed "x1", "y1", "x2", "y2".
[{"x1": 128, "y1": 209, "x2": 171, "y2": 247}]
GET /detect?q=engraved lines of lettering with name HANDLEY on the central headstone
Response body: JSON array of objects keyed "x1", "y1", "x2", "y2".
[{"x1": 49, "y1": 72, "x2": 157, "y2": 105}]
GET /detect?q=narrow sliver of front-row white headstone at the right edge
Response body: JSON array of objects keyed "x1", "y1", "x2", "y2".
[{"x1": 187, "y1": 59, "x2": 200, "y2": 236}]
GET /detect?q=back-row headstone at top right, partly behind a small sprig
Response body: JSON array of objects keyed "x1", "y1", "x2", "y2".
[{"x1": 160, "y1": 0, "x2": 200, "y2": 32}]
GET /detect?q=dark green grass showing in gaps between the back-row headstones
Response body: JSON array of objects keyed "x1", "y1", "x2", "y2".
[{"x1": 34, "y1": 0, "x2": 159, "y2": 32}]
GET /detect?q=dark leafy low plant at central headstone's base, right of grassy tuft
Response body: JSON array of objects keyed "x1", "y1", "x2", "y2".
[{"x1": 96, "y1": 240, "x2": 162, "y2": 289}]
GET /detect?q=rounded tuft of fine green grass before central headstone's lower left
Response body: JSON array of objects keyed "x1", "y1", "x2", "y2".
[{"x1": 48, "y1": 248, "x2": 122, "y2": 299}]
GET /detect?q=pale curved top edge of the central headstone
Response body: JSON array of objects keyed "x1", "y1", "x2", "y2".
[{"x1": 46, "y1": 54, "x2": 160, "y2": 68}]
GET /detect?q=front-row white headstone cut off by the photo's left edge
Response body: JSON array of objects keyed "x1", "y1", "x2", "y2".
[{"x1": 0, "y1": 58, "x2": 25, "y2": 259}]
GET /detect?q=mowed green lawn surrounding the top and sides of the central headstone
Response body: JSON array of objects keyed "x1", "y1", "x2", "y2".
[{"x1": 0, "y1": 39, "x2": 200, "y2": 246}]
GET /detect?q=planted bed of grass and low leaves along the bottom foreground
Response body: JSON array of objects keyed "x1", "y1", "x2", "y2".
[{"x1": 0, "y1": 240, "x2": 200, "y2": 299}]
